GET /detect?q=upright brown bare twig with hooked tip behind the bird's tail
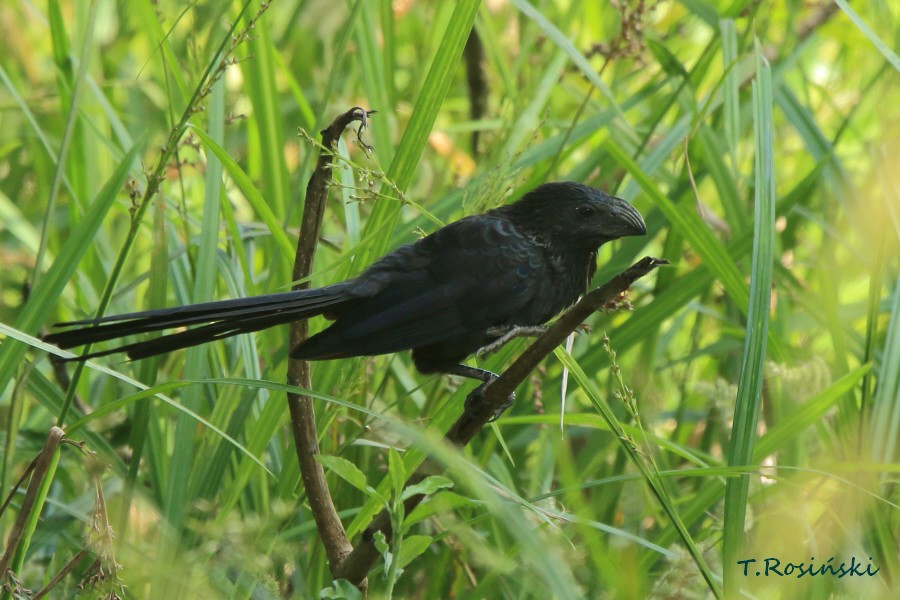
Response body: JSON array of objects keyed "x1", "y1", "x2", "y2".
[{"x1": 287, "y1": 107, "x2": 372, "y2": 573}]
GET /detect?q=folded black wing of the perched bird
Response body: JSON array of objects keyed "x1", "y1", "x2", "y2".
[{"x1": 292, "y1": 215, "x2": 545, "y2": 359}]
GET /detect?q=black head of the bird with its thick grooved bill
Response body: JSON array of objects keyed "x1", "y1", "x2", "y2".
[{"x1": 506, "y1": 181, "x2": 647, "y2": 251}]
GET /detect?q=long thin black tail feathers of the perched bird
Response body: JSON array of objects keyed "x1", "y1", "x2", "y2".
[{"x1": 44, "y1": 283, "x2": 354, "y2": 361}]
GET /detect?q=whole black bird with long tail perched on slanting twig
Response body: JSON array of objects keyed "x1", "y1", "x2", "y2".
[{"x1": 45, "y1": 182, "x2": 647, "y2": 398}]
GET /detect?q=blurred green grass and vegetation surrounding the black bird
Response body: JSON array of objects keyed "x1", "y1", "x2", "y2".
[{"x1": 0, "y1": 0, "x2": 900, "y2": 598}]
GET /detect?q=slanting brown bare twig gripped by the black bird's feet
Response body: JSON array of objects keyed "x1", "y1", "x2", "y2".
[{"x1": 332, "y1": 256, "x2": 669, "y2": 583}]
